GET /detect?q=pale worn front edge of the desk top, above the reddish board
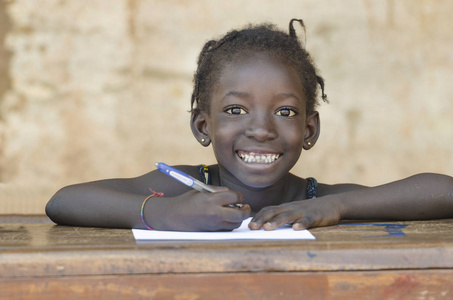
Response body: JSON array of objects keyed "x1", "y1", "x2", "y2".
[{"x1": 0, "y1": 247, "x2": 453, "y2": 278}]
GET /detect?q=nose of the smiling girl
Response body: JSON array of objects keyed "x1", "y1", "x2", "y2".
[{"x1": 245, "y1": 113, "x2": 278, "y2": 142}]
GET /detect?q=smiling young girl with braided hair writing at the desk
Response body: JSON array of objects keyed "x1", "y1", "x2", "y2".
[{"x1": 46, "y1": 19, "x2": 453, "y2": 231}]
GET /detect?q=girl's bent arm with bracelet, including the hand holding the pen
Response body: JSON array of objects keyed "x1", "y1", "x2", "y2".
[{"x1": 46, "y1": 167, "x2": 250, "y2": 231}]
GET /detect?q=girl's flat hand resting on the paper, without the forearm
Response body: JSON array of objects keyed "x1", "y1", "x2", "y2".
[{"x1": 249, "y1": 197, "x2": 341, "y2": 230}]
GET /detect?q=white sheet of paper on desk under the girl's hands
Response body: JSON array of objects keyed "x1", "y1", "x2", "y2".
[{"x1": 132, "y1": 218, "x2": 315, "y2": 241}]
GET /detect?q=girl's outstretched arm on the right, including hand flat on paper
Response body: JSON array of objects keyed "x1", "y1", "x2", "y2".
[{"x1": 250, "y1": 173, "x2": 453, "y2": 230}]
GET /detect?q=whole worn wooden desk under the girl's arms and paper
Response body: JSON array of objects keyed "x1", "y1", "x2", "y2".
[{"x1": 0, "y1": 219, "x2": 453, "y2": 300}]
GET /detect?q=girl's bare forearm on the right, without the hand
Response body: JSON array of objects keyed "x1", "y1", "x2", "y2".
[{"x1": 335, "y1": 174, "x2": 453, "y2": 220}]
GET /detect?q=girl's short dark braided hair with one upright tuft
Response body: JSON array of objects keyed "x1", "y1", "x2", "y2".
[{"x1": 191, "y1": 19, "x2": 327, "y2": 114}]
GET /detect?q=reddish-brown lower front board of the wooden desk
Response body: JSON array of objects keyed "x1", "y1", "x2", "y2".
[{"x1": 0, "y1": 270, "x2": 453, "y2": 300}]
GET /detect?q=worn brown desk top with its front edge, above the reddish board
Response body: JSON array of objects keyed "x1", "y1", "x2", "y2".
[{"x1": 0, "y1": 219, "x2": 453, "y2": 278}]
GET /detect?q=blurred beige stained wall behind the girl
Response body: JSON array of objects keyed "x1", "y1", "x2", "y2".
[{"x1": 0, "y1": 0, "x2": 453, "y2": 213}]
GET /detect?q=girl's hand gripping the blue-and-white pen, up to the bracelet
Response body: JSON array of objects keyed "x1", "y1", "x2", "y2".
[{"x1": 144, "y1": 186, "x2": 251, "y2": 231}]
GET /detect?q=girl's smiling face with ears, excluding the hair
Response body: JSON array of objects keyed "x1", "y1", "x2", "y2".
[{"x1": 191, "y1": 54, "x2": 319, "y2": 188}]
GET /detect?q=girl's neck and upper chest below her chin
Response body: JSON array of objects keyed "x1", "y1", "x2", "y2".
[{"x1": 210, "y1": 165, "x2": 306, "y2": 215}]
